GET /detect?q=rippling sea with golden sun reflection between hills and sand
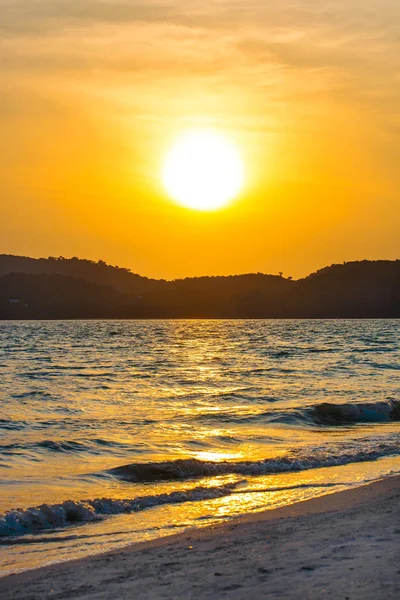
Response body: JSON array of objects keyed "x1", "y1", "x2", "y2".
[{"x1": 0, "y1": 320, "x2": 400, "y2": 575}]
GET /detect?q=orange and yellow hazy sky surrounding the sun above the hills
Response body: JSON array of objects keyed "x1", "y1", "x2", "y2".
[{"x1": 0, "y1": 0, "x2": 400, "y2": 278}]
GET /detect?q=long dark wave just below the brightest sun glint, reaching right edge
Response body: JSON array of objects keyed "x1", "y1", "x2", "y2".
[{"x1": 109, "y1": 435, "x2": 400, "y2": 483}]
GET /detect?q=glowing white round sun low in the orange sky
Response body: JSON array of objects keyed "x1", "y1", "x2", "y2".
[{"x1": 163, "y1": 129, "x2": 244, "y2": 211}]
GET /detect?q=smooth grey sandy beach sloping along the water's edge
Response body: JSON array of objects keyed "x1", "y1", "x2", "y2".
[{"x1": 0, "y1": 477, "x2": 400, "y2": 600}]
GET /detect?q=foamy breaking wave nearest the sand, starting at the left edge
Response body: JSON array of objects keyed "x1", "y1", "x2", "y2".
[{"x1": 0, "y1": 482, "x2": 240, "y2": 537}]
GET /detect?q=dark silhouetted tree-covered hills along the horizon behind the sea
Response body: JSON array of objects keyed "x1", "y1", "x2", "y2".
[{"x1": 0, "y1": 255, "x2": 400, "y2": 319}]
